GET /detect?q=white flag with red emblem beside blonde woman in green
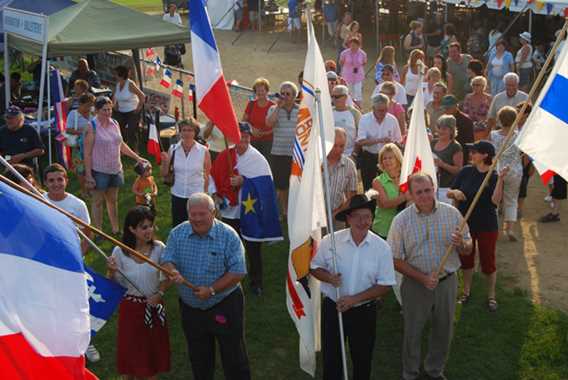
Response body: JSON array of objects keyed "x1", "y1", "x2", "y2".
[{"x1": 400, "y1": 79, "x2": 438, "y2": 193}]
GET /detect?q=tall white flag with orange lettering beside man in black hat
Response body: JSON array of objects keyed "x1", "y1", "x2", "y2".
[{"x1": 286, "y1": 12, "x2": 335, "y2": 376}]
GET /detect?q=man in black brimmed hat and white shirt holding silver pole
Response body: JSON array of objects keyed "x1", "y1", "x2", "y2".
[{"x1": 310, "y1": 194, "x2": 396, "y2": 380}]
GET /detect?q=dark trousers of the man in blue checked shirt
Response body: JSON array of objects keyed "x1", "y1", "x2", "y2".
[{"x1": 179, "y1": 288, "x2": 251, "y2": 380}]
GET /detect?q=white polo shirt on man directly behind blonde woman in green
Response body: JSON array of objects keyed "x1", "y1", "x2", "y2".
[{"x1": 357, "y1": 112, "x2": 402, "y2": 154}]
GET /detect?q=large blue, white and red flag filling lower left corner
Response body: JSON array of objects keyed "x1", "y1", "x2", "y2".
[{"x1": 0, "y1": 183, "x2": 96, "y2": 380}]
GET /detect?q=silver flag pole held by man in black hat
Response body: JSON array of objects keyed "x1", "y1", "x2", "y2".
[{"x1": 315, "y1": 88, "x2": 349, "y2": 380}]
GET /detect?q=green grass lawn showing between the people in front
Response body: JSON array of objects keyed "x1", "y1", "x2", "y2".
[{"x1": 65, "y1": 155, "x2": 568, "y2": 380}]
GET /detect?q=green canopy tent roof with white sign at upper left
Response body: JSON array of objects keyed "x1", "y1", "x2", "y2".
[{"x1": 8, "y1": 0, "x2": 189, "y2": 57}]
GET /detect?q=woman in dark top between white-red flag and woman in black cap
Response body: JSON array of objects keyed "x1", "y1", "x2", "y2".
[{"x1": 431, "y1": 115, "x2": 463, "y2": 203}]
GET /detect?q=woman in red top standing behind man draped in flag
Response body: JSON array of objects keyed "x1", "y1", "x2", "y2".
[{"x1": 243, "y1": 78, "x2": 274, "y2": 159}]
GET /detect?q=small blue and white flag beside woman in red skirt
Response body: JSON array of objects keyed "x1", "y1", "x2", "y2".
[{"x1": 85, "y1": 267, "x2": 126, "y2": 336}]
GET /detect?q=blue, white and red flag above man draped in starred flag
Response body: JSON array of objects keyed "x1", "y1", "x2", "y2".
[{"x1": 189, "y1": 0, "x2": 241, "y2": 143}]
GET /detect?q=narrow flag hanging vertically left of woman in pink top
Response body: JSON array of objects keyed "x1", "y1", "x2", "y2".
[{"x1": 49, "y1": 69, "x2": 71, "y2": 169}]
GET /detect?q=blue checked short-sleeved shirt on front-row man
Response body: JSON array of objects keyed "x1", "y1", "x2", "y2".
[{"x1": 161, "y1": 220, "x2": 247, "y2": 310}]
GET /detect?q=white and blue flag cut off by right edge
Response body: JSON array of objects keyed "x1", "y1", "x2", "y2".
[{"x1": 515, "y1": 30, "x2": 568, "y2": 180}]
